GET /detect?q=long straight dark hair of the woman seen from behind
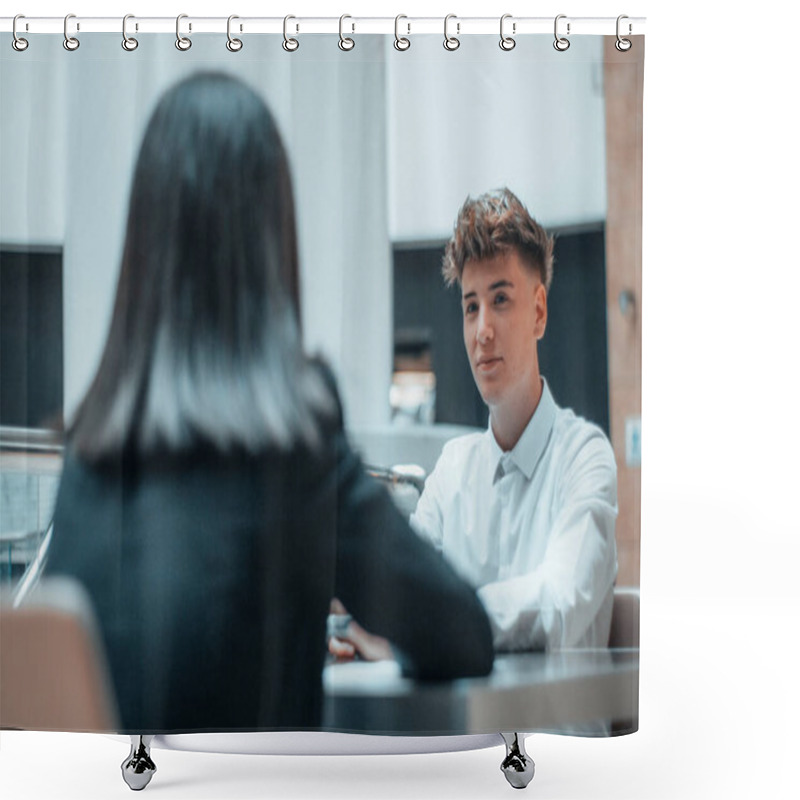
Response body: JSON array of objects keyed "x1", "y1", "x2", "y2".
[{"x1": 69, "y1": 73, "x2": 334, "y2": 461}]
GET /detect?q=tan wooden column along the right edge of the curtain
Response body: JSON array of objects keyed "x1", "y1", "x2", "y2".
[{"x1": 604, "y1": 36, "x2": 644, "y2": 586}]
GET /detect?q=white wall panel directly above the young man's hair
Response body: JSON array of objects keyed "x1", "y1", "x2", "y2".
[{"x1": 387, "y1": 36, "x2": 606, "y2": 242}]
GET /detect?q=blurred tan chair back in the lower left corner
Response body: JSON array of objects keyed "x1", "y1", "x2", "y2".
[{"x1": 0, "y1": 578, "x2": 118, "y2": 732}]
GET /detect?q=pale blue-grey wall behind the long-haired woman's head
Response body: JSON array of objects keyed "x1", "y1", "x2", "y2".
[{"x1": 0, "y1": 34, "x2": 392, "y2": 425}]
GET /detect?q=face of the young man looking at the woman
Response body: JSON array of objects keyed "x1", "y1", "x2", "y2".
[{"x1": 461, "y1": 249, "x2": 547, "y2": 409}]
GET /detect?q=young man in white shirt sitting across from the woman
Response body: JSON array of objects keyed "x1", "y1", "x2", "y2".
[{"x1": 330, "y1": 189, "x2": 617, "y2": 659}]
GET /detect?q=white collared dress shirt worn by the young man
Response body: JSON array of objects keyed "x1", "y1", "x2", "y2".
[{"x1": 411, "y1": 381, "x2": 617, "y2": 650}]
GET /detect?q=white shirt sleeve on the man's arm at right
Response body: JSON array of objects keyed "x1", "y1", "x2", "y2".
[{"x1": 478, "y1": 430, "x2": 617, "y2": 650}]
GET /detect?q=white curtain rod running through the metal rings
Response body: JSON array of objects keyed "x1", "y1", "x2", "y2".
[{"x1": 0, "y1": 14, "x2": 645, "y2": 36}]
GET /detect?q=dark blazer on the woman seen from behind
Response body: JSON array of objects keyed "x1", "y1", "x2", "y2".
[{"x1": 46, "y1": 388, "x2": 493, "y2": 733}]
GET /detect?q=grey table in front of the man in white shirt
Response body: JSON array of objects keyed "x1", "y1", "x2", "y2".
[{"x1": 322, "y1": 649, "x2": 639, "y2": 736}]
